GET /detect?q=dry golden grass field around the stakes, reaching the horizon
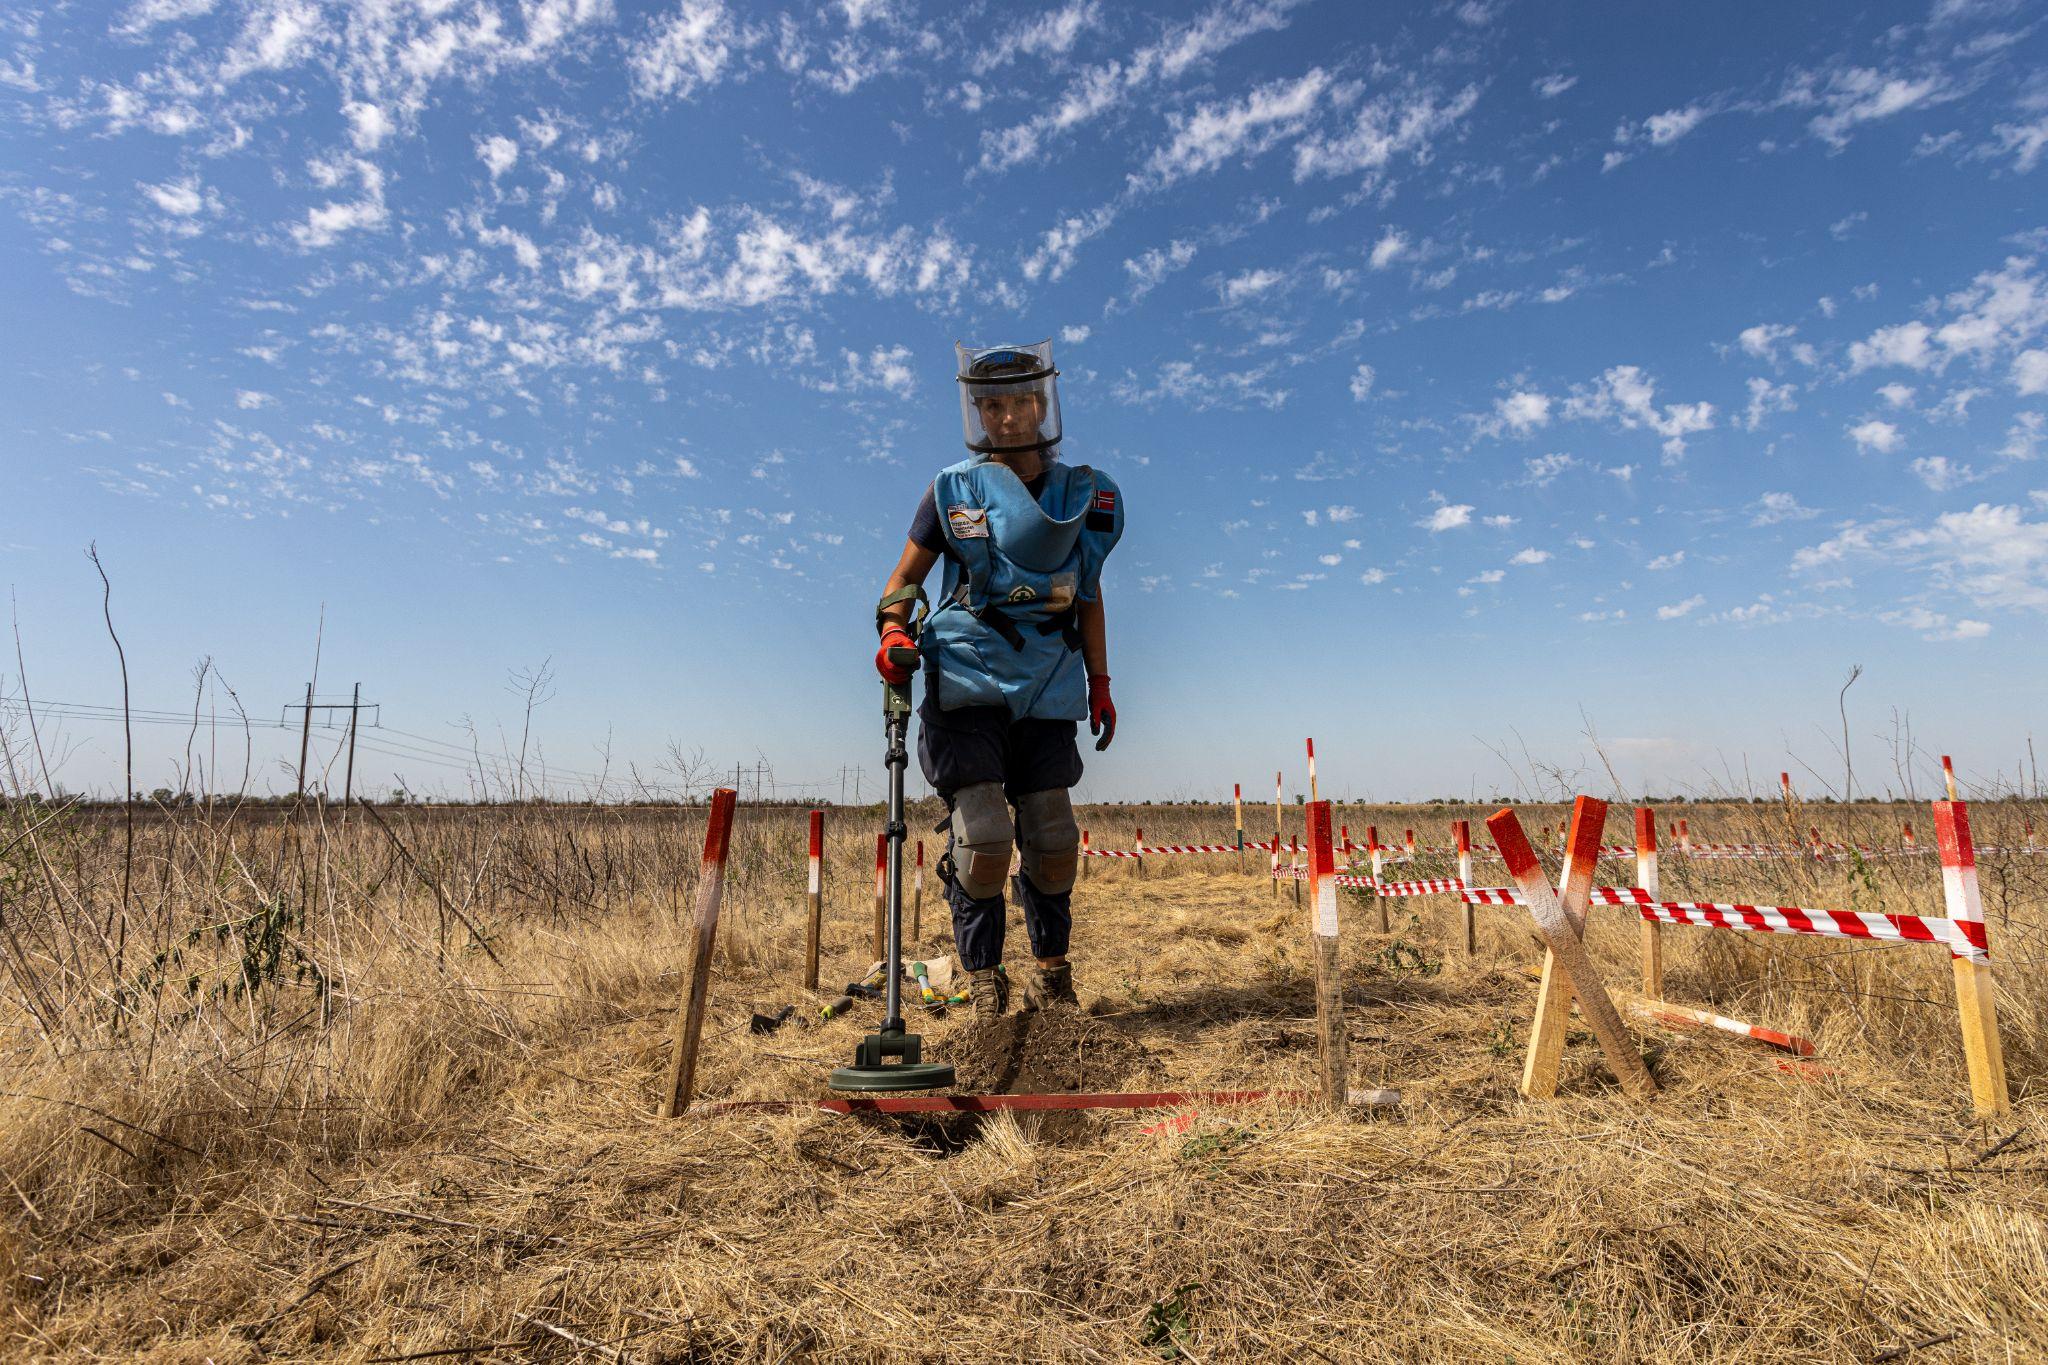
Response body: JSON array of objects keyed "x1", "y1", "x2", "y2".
[{"x1": 0, "y1": 802, "x2": 2048, "y2": 1365}]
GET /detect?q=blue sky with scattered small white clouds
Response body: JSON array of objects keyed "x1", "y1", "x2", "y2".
[{"x1": 0, "y1": 0, "x2": 2048, "y2": 798}]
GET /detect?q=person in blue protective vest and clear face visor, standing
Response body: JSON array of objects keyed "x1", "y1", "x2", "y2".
[{"x1": 874, "y1": 340, "x2": 1124, "y2": 1017}]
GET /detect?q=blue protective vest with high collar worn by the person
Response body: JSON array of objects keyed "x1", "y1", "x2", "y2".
[{"x1": 918, "y1": 456, "x2": 1124, "y2": 720}]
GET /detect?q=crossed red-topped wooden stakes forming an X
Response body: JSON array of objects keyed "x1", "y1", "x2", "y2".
[{"x1": 1487, "y1": 796, "x2": 1657, "y2": 1099}]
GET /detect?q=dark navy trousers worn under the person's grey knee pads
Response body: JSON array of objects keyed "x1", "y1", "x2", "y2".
[{"x1": 918, "y1": 694, "x2": 1081, "y2": 972}]
